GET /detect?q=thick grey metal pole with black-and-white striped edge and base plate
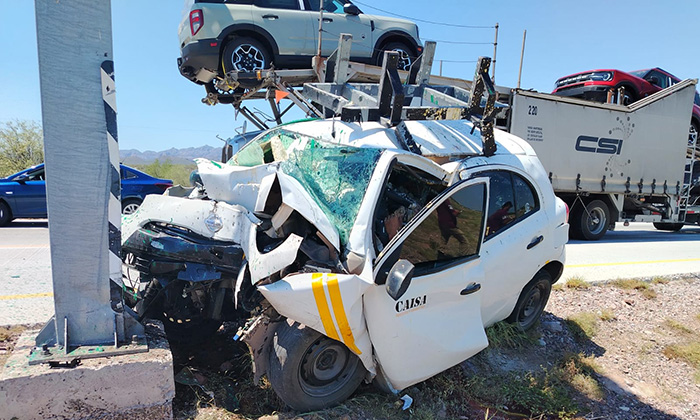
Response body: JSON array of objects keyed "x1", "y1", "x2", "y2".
[{"x1": 30, "y1": 0, "x2": 148, "y2": 364}]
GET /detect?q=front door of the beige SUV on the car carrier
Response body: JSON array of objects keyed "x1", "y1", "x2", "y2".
[{"x1": 308, "y1": 0, "x2": 374, "y2": 58}]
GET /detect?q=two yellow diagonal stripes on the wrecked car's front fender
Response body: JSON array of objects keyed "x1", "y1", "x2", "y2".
[{"x1": 311, "y1": 273, "x2": 362, "y2": 355}]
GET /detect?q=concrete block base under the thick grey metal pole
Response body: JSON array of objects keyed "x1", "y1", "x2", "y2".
[{"x1": 0, "y1": 321, "x2": 175, "y2": 420}]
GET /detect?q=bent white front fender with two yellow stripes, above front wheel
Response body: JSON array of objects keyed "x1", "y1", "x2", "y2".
[{"x1": 258, "y1": 273, "x2": 376, "y2": 376}]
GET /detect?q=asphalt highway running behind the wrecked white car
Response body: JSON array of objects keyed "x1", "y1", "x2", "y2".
[{"x1": 0, "y1": 220, "x2": 700, "y2": 325}]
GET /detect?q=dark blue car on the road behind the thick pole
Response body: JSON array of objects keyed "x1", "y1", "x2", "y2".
[{"x1": 0, "y1": 163, "x2": 173, "y2": 226}]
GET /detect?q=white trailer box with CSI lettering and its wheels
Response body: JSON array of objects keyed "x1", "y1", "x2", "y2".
[{"x1": 508, "y1": 80, "x2": 697, "y2": 240}]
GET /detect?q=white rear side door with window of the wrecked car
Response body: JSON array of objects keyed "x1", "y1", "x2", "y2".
[{"x1": 475, "y1": 170, "x2": 554, "y2": 326}]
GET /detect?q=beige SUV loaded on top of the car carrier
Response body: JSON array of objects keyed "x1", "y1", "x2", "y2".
[{"x1": 178, "y1": 0, "x2": 423, "y2": 84}]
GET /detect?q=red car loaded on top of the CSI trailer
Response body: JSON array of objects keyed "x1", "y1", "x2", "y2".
[{"x1": 552, "y1": 67, "x2": 700, "y2": 133}]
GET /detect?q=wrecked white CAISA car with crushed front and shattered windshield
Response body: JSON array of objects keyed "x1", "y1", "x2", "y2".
[{"x1": 123, "y1": 120, "x2": 568, "y2": 410}]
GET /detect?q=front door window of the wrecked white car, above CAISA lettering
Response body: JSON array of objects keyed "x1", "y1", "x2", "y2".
[{"x1": 399, "y1": 184, "x2": 486, "y2": 274}]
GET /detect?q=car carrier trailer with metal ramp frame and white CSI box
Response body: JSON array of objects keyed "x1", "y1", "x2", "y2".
[{"x1": 211, "y1": 36, "x2": 700, "y2": 240}]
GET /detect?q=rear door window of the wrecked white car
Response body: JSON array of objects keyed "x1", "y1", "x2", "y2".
[{"x1": 476, "y1": 171, "x2": 540, "y2": 239}]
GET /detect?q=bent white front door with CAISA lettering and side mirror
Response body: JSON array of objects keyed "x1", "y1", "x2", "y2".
[{"x1": 365, "y1": 179, "x2": 488, "y2": 389}]
